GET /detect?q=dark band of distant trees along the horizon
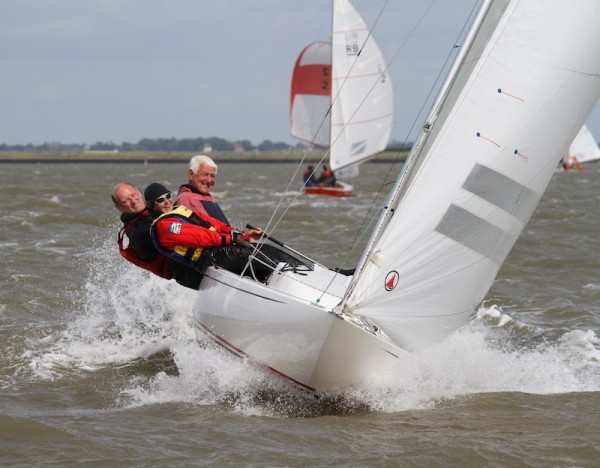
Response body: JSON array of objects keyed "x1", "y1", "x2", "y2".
[{"x1": 0, "y1": 137, "x2": 412, "y2": 153}]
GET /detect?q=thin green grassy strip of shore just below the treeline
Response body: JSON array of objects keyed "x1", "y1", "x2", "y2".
[{"x1": 0, "y1": 151, "x2": 407, "y2": 162}]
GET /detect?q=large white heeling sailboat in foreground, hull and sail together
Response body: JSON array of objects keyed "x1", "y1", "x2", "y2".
[{"x1": 194, "y1": 0, "x2": 600, "y2": 391}]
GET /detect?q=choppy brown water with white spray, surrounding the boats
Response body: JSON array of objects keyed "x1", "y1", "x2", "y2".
[{"x1": 0, "y1": 160, "x2": 600, "y2": 466}]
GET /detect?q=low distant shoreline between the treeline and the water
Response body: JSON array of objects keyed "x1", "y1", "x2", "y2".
[{"x1": 0, "y1": 151, "x2": 407, "y2": 164}]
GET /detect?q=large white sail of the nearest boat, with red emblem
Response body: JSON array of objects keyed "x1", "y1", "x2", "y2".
[{"x1": 344, "y1": 0, "x2": 600, "y2": 350}]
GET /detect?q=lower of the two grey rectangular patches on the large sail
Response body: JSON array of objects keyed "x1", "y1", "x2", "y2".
[{"x1": 435, "y1": 205, "x2": 514, "y2": 264}]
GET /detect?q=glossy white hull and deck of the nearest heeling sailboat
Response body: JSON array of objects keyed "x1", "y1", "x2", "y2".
[{"x1": 194, "y1": 266, "x2": 405, "y2": 392}]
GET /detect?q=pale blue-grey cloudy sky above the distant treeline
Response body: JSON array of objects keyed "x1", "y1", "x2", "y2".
[{"x1": 0, "y1": 0, "x2": 600, "y2": 144}]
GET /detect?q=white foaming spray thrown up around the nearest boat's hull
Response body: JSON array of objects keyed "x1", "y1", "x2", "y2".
[{"x1": 26, "y1": 241, "x2": 600, "y2": 417}]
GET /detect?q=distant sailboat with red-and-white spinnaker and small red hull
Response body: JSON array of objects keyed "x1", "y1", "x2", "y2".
[{"x1": 290, "y1": 0, "x2": 393, "y2": 196}]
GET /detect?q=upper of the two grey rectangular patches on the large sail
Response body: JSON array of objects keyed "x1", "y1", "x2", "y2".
[{"x1": 462, "y1": 164, "x2": 540, "y2": 223}]
